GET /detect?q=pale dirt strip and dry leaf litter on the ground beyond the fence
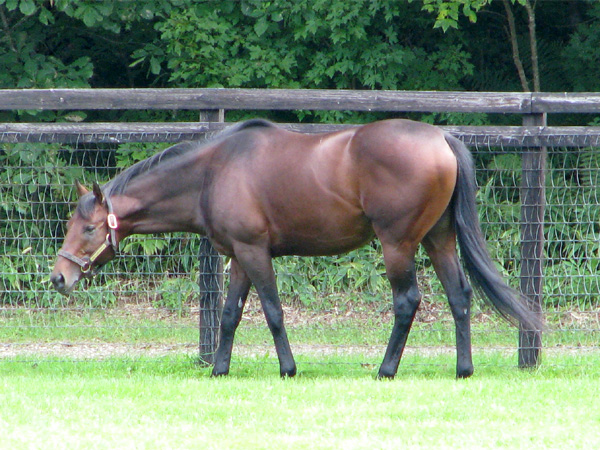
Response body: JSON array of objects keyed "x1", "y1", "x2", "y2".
[{"x1": 0, "y1": 297, "x2": 600, "y2": 360}]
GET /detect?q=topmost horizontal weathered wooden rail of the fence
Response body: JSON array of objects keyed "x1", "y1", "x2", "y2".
[{"x1": 0, "y1": 89, "x2": 600, "y2": 114}]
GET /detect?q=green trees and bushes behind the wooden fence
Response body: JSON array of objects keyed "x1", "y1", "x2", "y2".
[{"x1": 0, "y1": 0, "x2": 600, "y2": 312}]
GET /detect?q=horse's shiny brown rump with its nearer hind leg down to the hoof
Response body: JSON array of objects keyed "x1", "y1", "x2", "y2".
[{"x1": 351, "y1": 120, "x2": 457, "y2": 378}]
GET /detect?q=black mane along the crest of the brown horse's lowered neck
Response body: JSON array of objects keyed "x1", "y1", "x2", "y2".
[{"x1": 103, "y1": 119, "x2": 277, "y2": 196}]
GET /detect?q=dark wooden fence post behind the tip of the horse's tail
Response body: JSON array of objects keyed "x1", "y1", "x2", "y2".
[{"x1": 519, "y1": 114, "x2": 546, "y2": 368}]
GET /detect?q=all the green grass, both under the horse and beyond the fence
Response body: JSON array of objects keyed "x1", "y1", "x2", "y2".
[{"x1": 0, "y1": 300, "x2": 600, "y2": 450}]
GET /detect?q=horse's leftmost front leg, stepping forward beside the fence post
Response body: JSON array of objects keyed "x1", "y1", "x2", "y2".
[{"x1": 212, "y1": 258, "x2": 252, "y2": 376}]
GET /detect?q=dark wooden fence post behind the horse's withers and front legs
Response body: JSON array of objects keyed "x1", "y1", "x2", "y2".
[{"x1": 198, "y1": 109, "x2": 225, "y2": 364}]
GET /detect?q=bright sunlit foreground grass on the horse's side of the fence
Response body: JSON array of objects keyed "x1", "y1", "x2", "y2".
[{"x1": 0, "y1": 354, "x2": 600, "y2": 449}]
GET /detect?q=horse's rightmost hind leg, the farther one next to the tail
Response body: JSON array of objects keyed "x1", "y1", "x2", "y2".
[{"x1": 423, "y1": 214, "x2": 473, "y2": 378}]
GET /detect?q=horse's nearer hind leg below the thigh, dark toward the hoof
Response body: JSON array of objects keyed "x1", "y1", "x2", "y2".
[{"x1": 378, "y1": 240, "x2": 421, "y2": 378}]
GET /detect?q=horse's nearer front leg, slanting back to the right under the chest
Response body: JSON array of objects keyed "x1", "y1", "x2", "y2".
[{"x1": 234, "y1": 244, "x2": 296, "y2": 377}]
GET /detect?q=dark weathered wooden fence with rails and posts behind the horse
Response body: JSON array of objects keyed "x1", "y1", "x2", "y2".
[{"x1": 0, "y1": 89, "x2": 600, "y2": 367}]
